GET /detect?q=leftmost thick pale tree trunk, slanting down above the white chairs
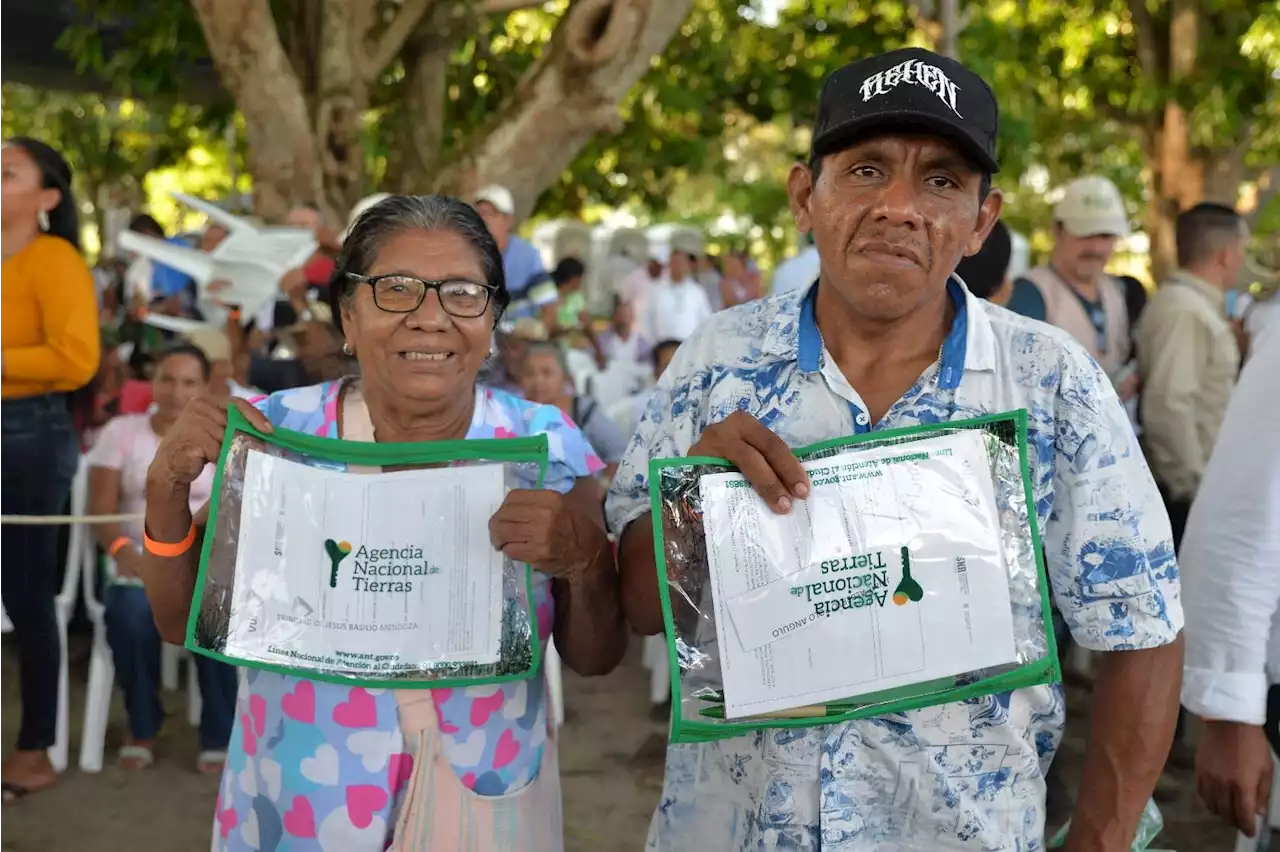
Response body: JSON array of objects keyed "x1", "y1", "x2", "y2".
[{"x1": 191, "y1": 0, "x2": 320, "y2": 220}]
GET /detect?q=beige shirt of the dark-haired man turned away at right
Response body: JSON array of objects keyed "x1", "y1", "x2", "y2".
[{"x1": 1138, "y1": 270, "x2": 1240, "y2": 499}]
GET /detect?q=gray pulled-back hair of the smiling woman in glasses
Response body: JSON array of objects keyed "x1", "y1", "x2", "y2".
[{"x1": 329, "y1": 196, "x2": 511, "y2": 334}]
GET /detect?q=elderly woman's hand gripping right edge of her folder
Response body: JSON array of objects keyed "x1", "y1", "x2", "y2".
[{"x1": 489, "y1": 490, "x2": 609, "y2": 581}]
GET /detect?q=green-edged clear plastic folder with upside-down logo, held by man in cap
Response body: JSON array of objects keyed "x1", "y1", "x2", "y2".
[{"x1": 650, "y1": 412, "x2": 1060, "y2": 742}]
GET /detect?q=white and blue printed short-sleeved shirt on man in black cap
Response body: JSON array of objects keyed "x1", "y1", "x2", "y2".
[{"x1": 607, "y1": 283, "x2": 1183, "y2": 852}]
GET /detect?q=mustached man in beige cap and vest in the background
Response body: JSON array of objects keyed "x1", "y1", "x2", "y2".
[{"x1": 1007, "y1": 177, "x2": 1138, "y2": 400}]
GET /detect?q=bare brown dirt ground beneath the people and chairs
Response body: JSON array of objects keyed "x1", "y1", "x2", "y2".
[{"x1": 0, "y1": 637, "x2": 1259, "y2": 852}]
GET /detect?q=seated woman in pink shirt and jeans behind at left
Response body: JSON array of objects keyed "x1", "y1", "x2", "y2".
[{"x1": 90, "y1": 344, "x2": 236, "y2": 771}]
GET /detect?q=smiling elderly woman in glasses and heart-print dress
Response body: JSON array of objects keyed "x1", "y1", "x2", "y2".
[{"x1": 142, "y1": 196, "x2": 626, "y2": 852}]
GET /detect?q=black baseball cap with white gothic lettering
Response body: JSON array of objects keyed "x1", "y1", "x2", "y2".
[{"x1": 810, "y1": 47, "x2": 1000, "y2": 173}]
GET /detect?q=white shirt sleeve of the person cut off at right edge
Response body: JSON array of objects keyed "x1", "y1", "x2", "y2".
[{"x1": 1180, "y1": 324, "x2": 1280, "y2": 725}]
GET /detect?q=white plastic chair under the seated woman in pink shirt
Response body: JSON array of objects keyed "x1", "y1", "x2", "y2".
[{"x1": 79, "y1": 542, "x2": 202, "y2": 773}]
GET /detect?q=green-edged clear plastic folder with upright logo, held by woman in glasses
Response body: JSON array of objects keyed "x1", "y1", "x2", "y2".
[{"x1": 187, "y1": 401, "x2": 547, "y2": 688}]
